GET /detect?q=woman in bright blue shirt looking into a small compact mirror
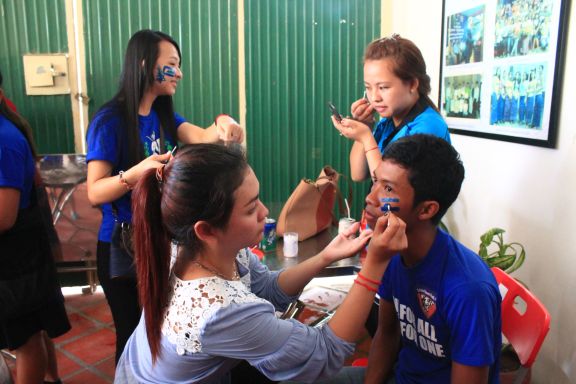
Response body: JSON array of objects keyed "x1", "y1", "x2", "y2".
[{"x1": 332, "y1": 34, "x2": 450, "y2": 181}]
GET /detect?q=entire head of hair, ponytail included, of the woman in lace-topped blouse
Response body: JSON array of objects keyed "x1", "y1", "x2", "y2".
[{"x1": 132, "y1": 144, "x2": 248, "y2": 362}]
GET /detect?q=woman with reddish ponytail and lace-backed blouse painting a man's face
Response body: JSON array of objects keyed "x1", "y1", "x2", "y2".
[{"x1": 115, "y1": 144, "x2": 406, "y2": 383}]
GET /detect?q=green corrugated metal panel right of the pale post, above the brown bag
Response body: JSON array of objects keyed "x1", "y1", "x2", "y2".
[{"x1": 245, "y1": 0, "x2": 380, "y2": 218}]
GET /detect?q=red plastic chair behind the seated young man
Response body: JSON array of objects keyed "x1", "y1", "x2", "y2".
[{"x1": 492, "y1": 267, "x2": 550, "y2": 384}]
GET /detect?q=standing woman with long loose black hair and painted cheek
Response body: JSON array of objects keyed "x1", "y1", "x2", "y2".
[{"x1": 86, "y1": 30, "x2": 244, "y2": 362}]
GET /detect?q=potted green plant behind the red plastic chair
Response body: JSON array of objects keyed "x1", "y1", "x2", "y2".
[{"x1": 478, "y1": 228, "x2": 531, "y2": 384}]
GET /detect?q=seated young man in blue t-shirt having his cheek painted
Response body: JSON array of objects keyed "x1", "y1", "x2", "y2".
[{"x1": 312, "y1": 134, "x2": 502, "y2": 384}]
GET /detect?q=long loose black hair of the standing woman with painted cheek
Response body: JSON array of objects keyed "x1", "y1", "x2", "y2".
[{"x1": 93, "y1": 29, "x2": 182, "y2": 166}]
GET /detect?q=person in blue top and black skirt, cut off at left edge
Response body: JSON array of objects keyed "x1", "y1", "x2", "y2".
[{"x1": 0, "y1": 73, "x2": 70, "y2": 384}]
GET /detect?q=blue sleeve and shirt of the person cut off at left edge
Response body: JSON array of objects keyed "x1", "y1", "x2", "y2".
[{"x1": 0, "y1": 115, "x2": 36, "y2": 209}]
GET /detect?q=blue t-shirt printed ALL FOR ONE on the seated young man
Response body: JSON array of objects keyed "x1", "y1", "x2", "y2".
[{"x1": 378, "y1": 230, "x2": 502, "y2": 384}]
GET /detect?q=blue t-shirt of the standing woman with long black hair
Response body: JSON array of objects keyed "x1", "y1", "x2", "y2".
[{"x1": 86, "y1": 108, "x2": 186, "y2": 242}]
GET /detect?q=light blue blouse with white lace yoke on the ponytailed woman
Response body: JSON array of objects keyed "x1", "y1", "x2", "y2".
[{"x1": 115, "y1": 250, "x2": 354, "y2": 384}]
